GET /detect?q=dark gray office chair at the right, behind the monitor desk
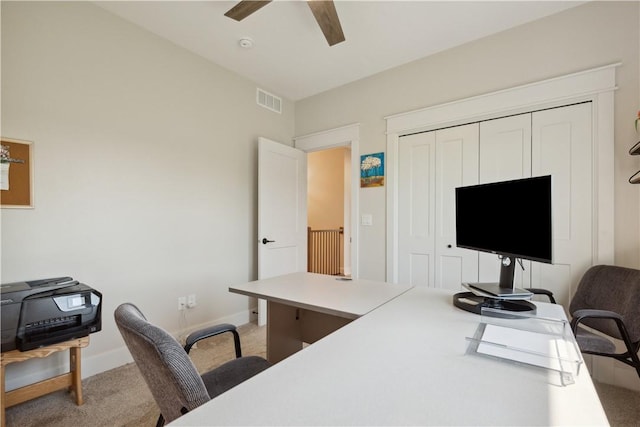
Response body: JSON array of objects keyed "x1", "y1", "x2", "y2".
[{"x1": 569, "y1": 265, "x2": 640, "y2": 377}]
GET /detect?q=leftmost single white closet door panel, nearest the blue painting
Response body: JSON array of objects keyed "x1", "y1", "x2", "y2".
[{"x1": 398, "y1": 132, "x2": 435, "y2": 287}]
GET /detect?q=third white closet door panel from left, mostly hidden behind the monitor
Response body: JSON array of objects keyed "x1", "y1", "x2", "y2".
[{"x1": 479, "y1": 113, "x2": 531, "y2": 288}]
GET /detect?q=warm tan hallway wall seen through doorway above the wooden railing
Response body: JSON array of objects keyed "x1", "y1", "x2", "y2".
[{"x1": 307, "y1": 147, "x2": 346, "y2": 230}]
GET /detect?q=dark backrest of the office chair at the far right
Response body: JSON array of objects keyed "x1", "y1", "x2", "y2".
[{"x1": 569, "y1": 265, "x2": 640, "y2": 343}]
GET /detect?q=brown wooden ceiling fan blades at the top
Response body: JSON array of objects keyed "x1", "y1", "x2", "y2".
[{"x1": 224, "y1": 0, "x2": 345, "y2": 46}]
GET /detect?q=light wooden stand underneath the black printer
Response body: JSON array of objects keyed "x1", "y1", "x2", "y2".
[{"x1": 0, "y1": 336, "x2": 89, "y2": 427}]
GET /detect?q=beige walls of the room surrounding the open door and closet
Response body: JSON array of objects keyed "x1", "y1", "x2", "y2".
[{"x1": 0, "y1": 2, "x2": 640, "y2": 388}]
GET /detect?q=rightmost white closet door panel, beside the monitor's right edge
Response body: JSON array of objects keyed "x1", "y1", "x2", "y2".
[{"x1": 532, "y1": 103, "x2": 593, "y2": 307}]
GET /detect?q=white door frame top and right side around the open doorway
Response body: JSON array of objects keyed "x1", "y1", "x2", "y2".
[{"x1": 293, "y1": 123, "x2": 360, "y2": 279}]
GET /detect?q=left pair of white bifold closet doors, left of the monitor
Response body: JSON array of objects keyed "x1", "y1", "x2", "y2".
[{"x1": 398, "y1": 124, "x2": 478, "y2": 290}]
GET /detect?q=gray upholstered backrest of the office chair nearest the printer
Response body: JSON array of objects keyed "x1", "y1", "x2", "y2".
[{"x1": 114, "y1": 303, "x2": 210, "y2": 423}]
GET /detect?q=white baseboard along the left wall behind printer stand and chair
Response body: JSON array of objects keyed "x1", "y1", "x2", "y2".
[{"x1": 5, "y1": 307, "x2": 257, "y2": 391}]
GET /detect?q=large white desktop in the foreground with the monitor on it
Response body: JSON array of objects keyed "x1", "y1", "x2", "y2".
[{"x1": 173, "y1": 280, "x2": 608, "y2": 426}]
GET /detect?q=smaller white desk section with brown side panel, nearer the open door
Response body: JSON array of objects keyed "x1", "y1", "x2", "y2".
[{"x1": 229, "y1": 272, "x2": 411, "y2": 363}]
